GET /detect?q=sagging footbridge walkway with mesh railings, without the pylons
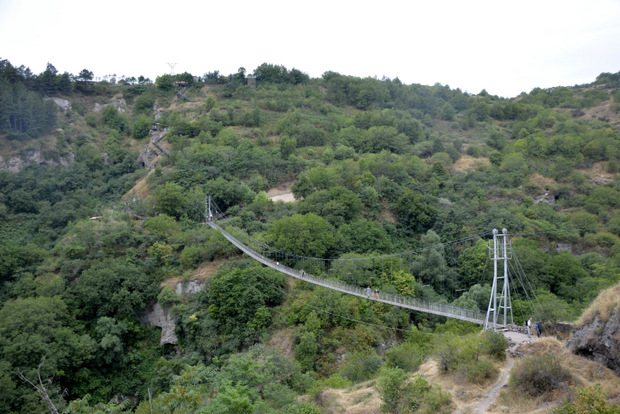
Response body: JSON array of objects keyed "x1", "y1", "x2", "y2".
[{"x1": 207, "y1": 222, "x2": 490, "y2": 325}]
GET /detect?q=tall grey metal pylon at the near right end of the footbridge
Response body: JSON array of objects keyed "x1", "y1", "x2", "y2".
[{"x1": 484, "y1": 229, "x2": 513, "y2": 330}]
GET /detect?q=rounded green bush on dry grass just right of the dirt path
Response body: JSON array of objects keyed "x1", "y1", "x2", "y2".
[{"x1": 510, "y1": 354, "x2": 572, "y2": 397}]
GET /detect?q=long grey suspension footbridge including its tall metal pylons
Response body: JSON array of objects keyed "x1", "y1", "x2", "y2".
[{"x1": 205, "y1": 197, "x2": 540, "y2": 330}]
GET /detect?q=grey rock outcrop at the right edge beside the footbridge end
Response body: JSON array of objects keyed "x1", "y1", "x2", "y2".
[{"x1": 568, "y1": 309, "x2": 620, "y2": 375}]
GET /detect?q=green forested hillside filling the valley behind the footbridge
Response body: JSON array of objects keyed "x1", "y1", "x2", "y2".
[{"x1": 0, "y1": 60, "x2": 620, "y2": 414}]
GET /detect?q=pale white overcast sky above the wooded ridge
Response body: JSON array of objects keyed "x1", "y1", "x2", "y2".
[{"x1": 0, "y1": 0, "x2": 620, "y2": 97}]
